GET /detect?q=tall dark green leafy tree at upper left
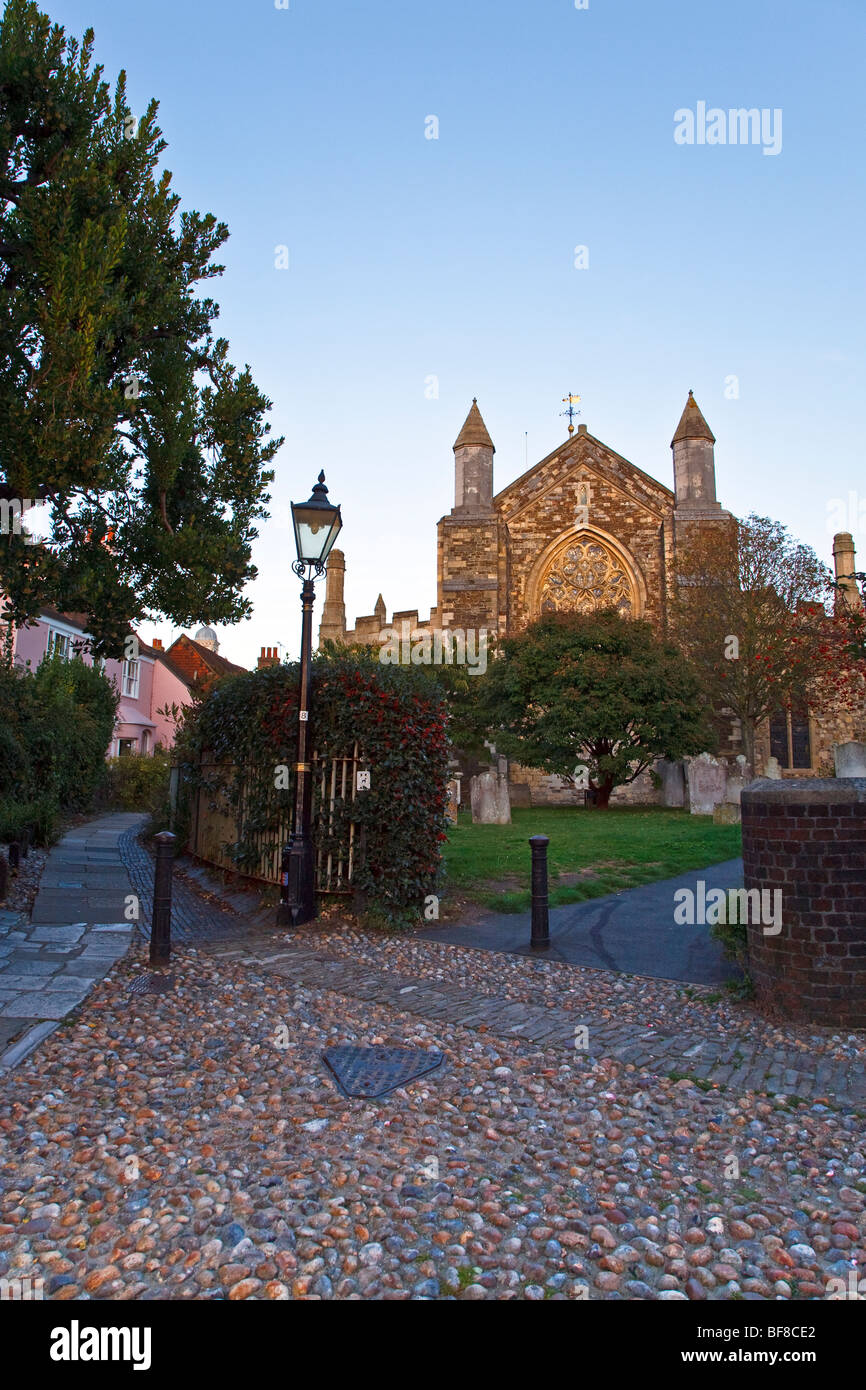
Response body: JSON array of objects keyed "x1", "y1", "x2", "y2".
[{"x1": 0, "y1": 0, "x2": 282, "y2": 656}]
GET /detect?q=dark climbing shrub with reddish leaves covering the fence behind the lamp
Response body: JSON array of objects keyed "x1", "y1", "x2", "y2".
[{"x1": 175, "y1": 648, "x2": 449, "y2": 926}]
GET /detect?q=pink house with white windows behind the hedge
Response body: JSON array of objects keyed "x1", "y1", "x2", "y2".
[{"x1": 5, "y1": 607, "x2": 198, "y2": 758}]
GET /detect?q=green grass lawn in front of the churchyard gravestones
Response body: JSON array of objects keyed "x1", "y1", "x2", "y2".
[{"x1": 445, "y1": 806, "x2": 741, "y2": 912}]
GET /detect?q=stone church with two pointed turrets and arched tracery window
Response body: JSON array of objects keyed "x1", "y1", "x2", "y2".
[{"x1": 320, "y1": 391, "x2": 859, "y2": 805}]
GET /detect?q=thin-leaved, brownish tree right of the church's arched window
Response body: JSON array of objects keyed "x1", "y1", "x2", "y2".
[{"x1": 671, "y1": 514, "x2": 830, "y2": 767}]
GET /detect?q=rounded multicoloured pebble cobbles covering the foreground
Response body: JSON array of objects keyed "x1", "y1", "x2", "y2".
[{"x1": 0, "y1": 940, "x2": 866, "y2": 1301}]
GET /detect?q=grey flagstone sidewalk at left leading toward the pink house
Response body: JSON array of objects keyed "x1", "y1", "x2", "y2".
[{"x1": 0, "y1": 813, "x2": 142, "y2": 1070}]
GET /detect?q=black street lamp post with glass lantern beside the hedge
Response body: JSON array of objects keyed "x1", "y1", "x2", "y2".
[{"x1": 277, "y1": 473, "x2": 343, "y2": 927}]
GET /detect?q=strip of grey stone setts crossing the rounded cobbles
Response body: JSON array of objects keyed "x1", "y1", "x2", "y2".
[{"x1": 201, "y1": 933, "x2": 866, "y2": 1109}]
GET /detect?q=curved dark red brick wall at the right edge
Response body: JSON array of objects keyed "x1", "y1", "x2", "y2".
[{"x1": 742, "y1": 777, "x2": 866, "y2": 1029}]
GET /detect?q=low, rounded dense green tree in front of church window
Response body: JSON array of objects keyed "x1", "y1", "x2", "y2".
[{"x1": 477, "y1": 609, "x2": 712, "y2": 808}]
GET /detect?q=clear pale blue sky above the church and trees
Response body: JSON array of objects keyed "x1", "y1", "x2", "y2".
[{"x1": 42, "y1": 0, "x2": 866, "y2": 666}]
